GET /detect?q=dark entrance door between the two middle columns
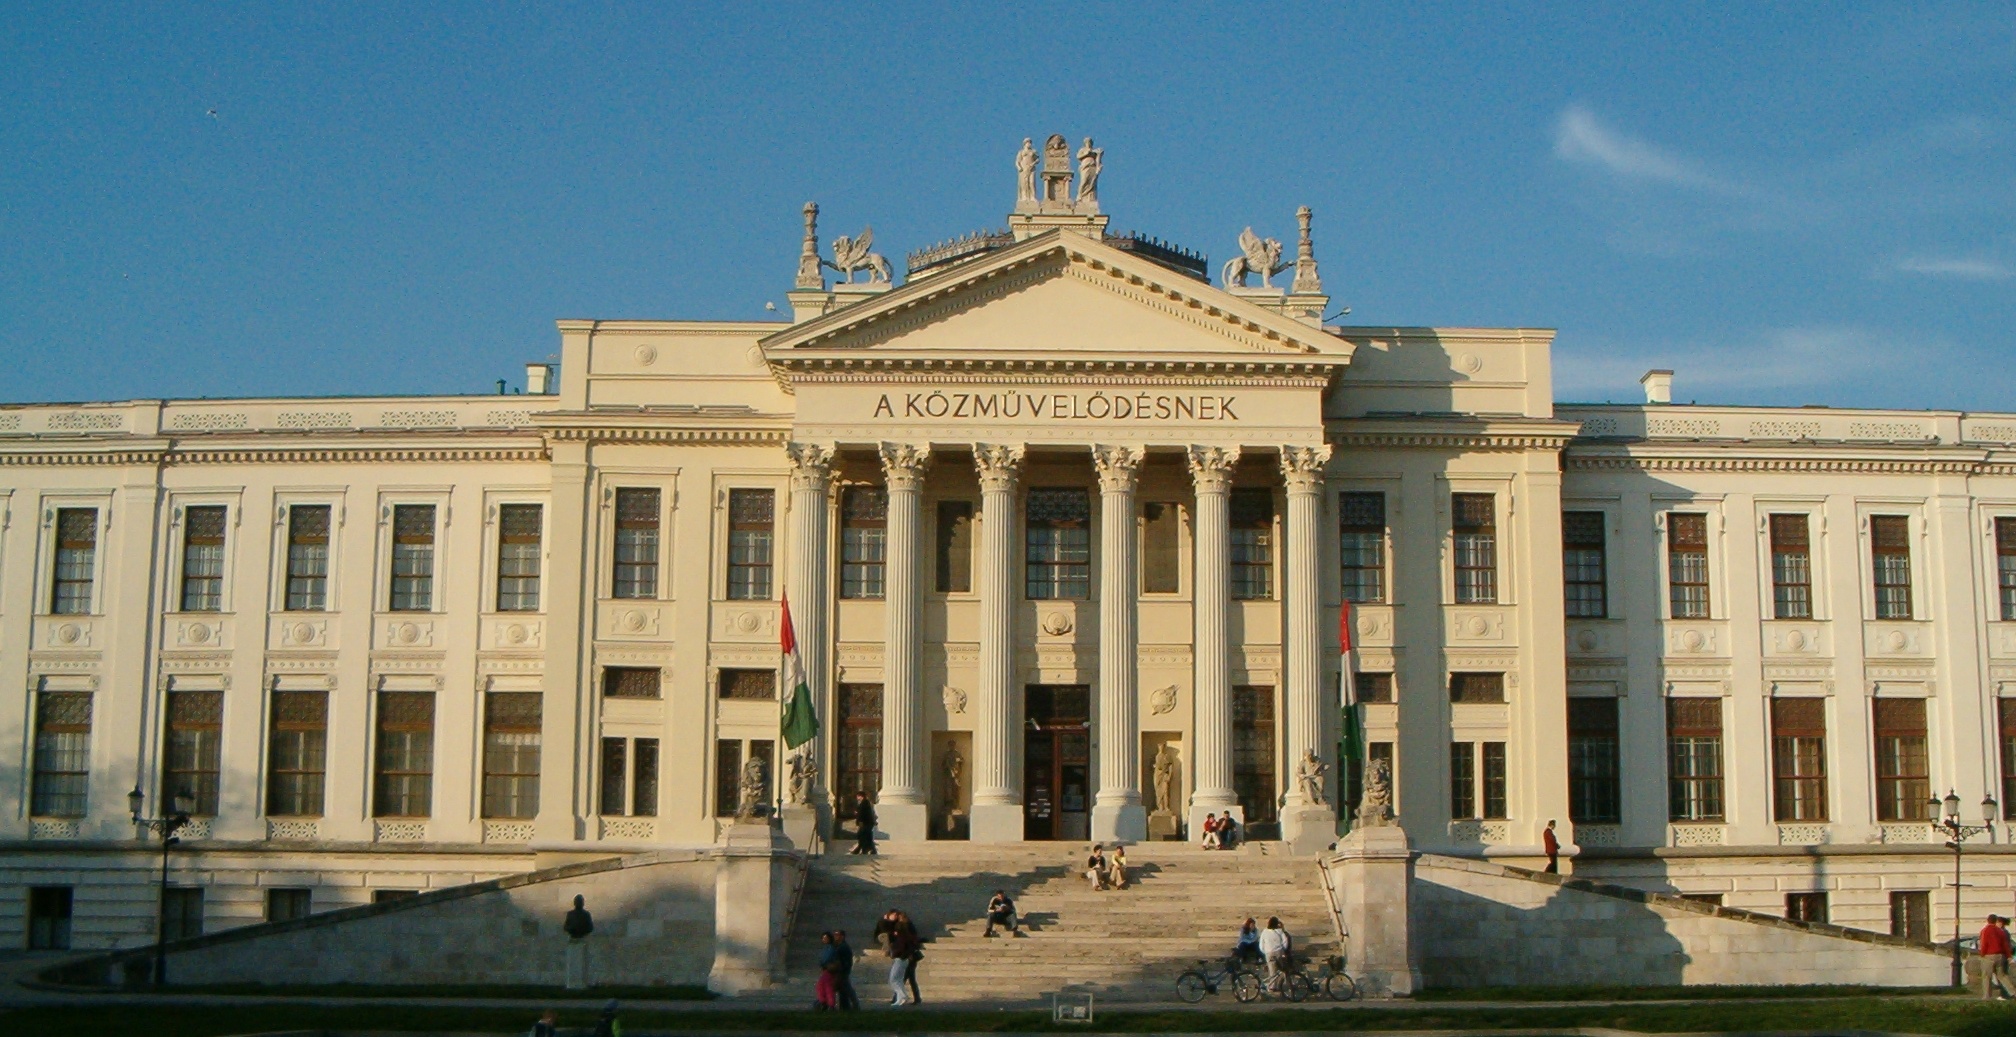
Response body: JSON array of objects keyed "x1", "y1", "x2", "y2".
[{"x1": 1022, "y1": 684, "x2": 1093, "y2": 841}]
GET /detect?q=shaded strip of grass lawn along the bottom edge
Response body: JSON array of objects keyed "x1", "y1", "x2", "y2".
[{"x1": 0, "y1": 997, "x2": 2016, "y2": 1037}]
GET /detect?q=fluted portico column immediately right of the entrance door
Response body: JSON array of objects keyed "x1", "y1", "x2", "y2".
[{"x1": 1093, "y1": 446, "x2": 1147, "y2": 841}]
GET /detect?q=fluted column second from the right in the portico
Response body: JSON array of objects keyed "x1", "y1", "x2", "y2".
[{"x1": 1189, "y1": 446, "x2": 1246, "y2": 833}]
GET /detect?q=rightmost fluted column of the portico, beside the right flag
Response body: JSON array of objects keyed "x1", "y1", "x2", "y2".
[{"x1": 1280, "y1": 444, "x2": 1337, "y2": 853}]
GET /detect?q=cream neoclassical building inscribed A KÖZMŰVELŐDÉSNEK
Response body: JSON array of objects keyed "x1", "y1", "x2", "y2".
[{"x1": 0, "y1": 137, "x2": 2016, "y2": 948}]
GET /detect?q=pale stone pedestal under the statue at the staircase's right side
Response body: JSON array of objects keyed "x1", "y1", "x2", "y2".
[{"x1": 1329, "y1": 825, "x2": 1421, "y2": 997}]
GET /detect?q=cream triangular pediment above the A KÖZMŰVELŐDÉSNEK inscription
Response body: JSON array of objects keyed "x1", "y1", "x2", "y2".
[{"x1": 762, "y1": 232, "x2": 1351, "y2": 363}]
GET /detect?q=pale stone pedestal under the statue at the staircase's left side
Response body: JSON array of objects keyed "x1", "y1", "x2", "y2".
[{"x1": 708, "y1": 819, "x2": 788, "y2": 995}]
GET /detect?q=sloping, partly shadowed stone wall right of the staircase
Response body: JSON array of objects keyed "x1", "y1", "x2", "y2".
[{"x1": 1411, "y1": 853, "x2": 1951, "y2": 987}]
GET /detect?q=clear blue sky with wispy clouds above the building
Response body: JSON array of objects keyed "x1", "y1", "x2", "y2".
[{"x1": 0, "y1": 0, "x2": 2016, "y2": 410}]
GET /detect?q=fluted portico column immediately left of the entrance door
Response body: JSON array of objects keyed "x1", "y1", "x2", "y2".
[{"x1": 970, "y1": 444, "x2": 1022, "y2": 843}]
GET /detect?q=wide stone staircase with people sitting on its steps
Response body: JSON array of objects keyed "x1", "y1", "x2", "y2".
[{"x1": 766, "y1": 843, "x2": 1339, "y2": 1005}]
